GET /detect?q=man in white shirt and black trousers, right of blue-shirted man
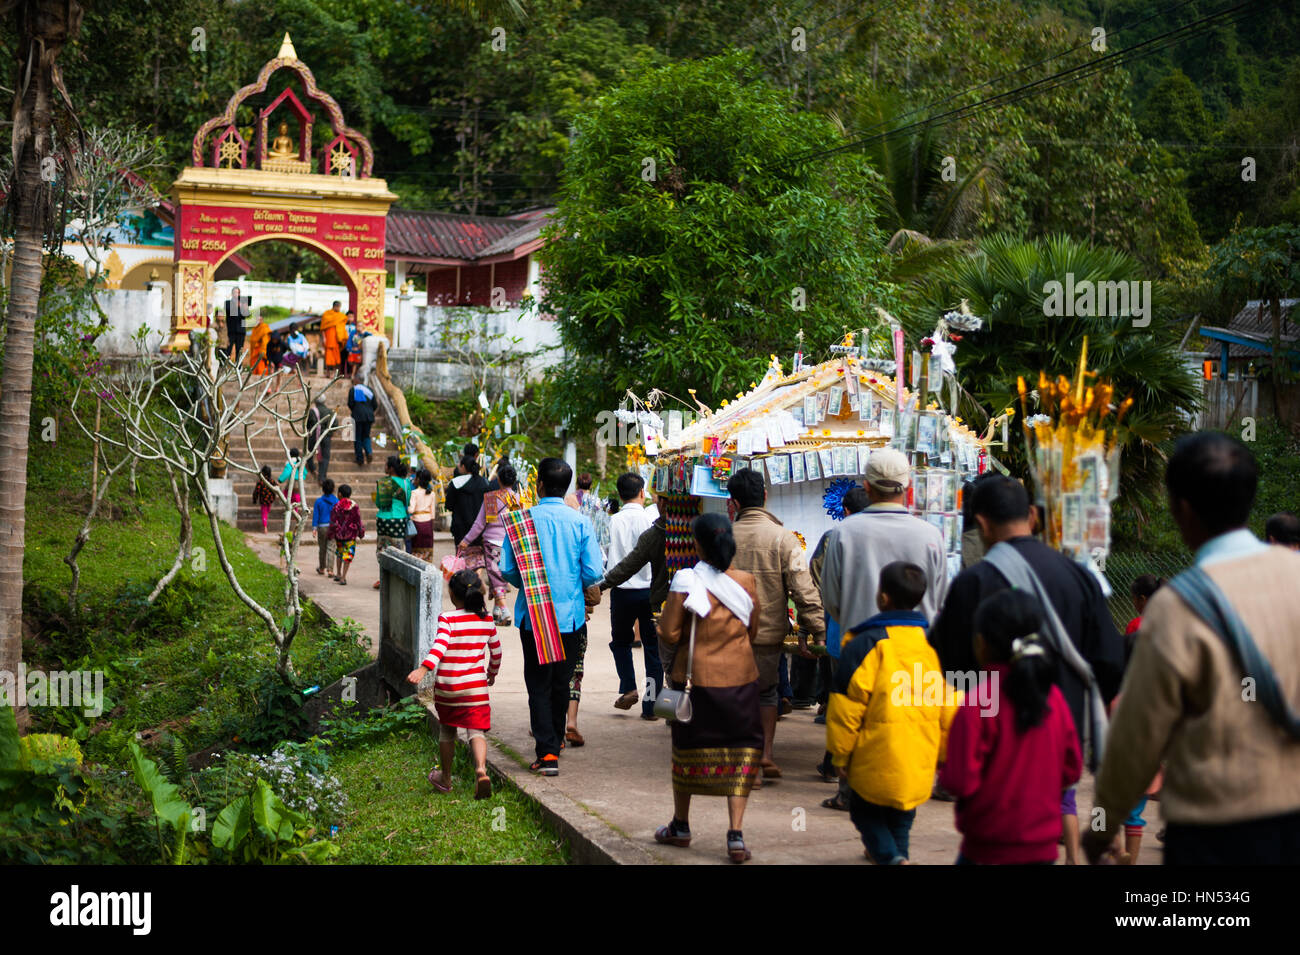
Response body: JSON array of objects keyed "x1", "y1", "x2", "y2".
[{"x1": 605, "y1": 472, "x2": 663, "y2": 720}]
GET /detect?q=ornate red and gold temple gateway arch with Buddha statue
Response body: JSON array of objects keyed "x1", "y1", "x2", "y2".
[{"x1": 164, "y1": 34, "x2": 397, "y2": 351}]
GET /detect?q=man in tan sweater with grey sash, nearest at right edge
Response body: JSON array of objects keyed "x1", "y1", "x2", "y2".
[{"x1": 1084, "y1": 431, "x2": 1300, "y2": 865}]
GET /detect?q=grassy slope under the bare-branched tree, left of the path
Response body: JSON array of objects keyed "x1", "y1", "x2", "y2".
[{"x1": 23, "y1": 424, "x2": 369, "y2": 765}]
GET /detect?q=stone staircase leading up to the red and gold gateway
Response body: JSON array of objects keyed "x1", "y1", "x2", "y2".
[{"x1": 226, "y1": 376, "x2": 397, "y2": 537}]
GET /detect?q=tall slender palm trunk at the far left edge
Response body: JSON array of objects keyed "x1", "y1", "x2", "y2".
[{"x1": 0, "y1": 0, "x2": 82, "y2": 725}]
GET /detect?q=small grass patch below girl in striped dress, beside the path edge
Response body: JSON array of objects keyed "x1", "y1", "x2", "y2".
[{"x1": 330, "y1": 732, "x2": 568, "y2": 865}]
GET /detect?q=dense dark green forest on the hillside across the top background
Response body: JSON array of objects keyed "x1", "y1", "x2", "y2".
[{"x1": 0, "y1": 0, "x2": 1300, "y2": 286}]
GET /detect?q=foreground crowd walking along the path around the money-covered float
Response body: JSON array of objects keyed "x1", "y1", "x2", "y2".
[{"x1": 400, "y1": 433, "x2": 1300, "y2": 865}]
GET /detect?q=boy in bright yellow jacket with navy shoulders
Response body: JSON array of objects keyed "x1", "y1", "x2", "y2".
[{"x1": 826, "y1": 561, "x2": 961, "y2": 865}]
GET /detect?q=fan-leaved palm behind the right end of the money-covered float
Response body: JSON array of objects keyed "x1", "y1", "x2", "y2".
[{"x1": 904, "y1": 235, "x2": 1201, "y2": 499}]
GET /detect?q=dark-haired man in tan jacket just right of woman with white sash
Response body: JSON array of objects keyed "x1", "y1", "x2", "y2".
[{"x1": 727, "y1": 470, "x2": 826, "y2": 778}]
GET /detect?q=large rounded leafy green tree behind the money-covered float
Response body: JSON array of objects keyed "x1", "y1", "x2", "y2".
[{"x1": 541, "y1": 55, "x2": 893, "y2": 414}]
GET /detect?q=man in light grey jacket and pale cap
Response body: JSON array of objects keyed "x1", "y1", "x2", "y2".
[{"x1": 822, "y1": 448, "x2": 948, "y2": 634}]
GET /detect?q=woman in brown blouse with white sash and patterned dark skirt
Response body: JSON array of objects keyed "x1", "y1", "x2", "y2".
[{"x1": 655, "y1": 515, "x2": 763, "y2": 863}]
